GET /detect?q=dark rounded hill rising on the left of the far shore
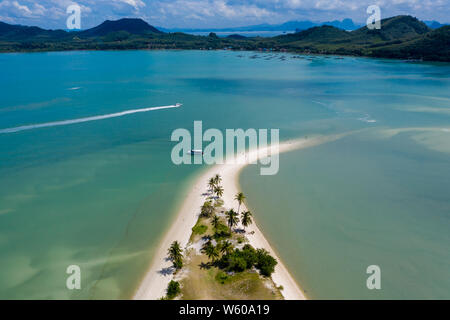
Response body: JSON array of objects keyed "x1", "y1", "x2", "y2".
[{"x1": 79, "y1": 18, "x2": 162, "y2": 37}]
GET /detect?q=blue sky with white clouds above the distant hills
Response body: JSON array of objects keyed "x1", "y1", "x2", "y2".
[{"x1": 0, "y1": 0, "x2": 450, "y2": 29}]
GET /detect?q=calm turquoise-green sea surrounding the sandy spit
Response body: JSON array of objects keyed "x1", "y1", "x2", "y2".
[{"x1": 0, "y1": 51, "x2": 450, "y2": 299}]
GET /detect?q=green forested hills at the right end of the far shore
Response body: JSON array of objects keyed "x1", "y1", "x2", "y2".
[{"x1": 268, "y1": 16, "x2": 450, "y2": 61}]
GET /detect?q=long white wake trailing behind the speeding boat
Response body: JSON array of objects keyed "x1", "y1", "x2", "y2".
[{"x1": 0, "y1": 103, "x2": 182, "y2": 133}]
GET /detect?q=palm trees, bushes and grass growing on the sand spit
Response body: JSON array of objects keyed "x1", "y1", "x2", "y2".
[{"x1": 172, "y1": 175, "x2": 282, "y2": 299}]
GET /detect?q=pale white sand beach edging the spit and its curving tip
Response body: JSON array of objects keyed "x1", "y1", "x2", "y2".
[{"x1": 134, "y1": 135, "x2": 343, "y2": 300}]
